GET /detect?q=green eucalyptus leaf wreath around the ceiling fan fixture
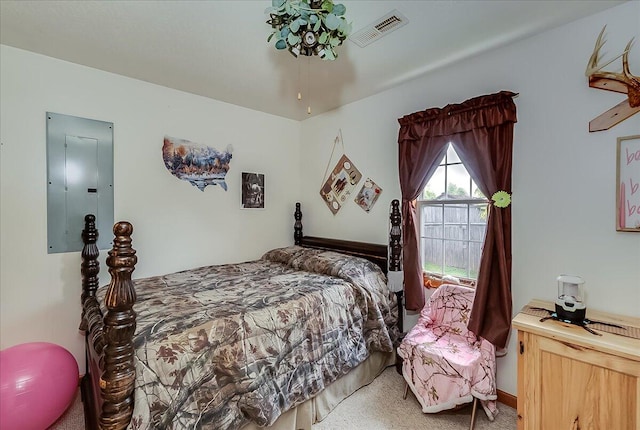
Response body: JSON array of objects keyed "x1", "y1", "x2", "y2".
[{"x1": 265, "y1": 0, "x2": 351, "y2": 60}]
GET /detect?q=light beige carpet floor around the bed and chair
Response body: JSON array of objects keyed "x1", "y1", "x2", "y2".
[{"x1": 49, "y1": 367, "x2": 517, "y2": 430}]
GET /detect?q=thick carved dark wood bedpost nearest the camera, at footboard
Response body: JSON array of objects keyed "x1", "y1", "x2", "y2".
[{"x1": 100, "y1": 222, "x2": 138, "y2": 430}]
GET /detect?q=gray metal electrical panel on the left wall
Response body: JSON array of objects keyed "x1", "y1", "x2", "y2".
[{"x1": 47, "y1": 112, "x2": 113, "y2": 254}]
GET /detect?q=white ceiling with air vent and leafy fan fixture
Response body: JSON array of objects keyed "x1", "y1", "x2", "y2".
[{"x1": 0, "y1": 0, "x2": 623, "y2": 120}]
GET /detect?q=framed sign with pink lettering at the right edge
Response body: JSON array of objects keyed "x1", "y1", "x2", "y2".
[{"x1": 616, "y1": 134, "x2": 640, "y2": 232}]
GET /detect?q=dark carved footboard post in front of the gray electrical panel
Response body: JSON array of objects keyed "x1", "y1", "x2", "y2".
[{"x1": 80, "y1": 214, "x2": 100, "y2": 331}]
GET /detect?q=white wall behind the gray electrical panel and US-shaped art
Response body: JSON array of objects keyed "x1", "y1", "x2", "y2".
[{"x1": 0, "y1": 46, "x2": 300, "y2": 372}]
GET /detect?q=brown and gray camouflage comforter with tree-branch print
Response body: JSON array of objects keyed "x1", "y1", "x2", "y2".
[{"x1": 102, "y1": 246, "x2": 396, "y2": 430}]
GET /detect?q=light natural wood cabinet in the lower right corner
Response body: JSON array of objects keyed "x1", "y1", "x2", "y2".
[{"x1": 513, "y1": 300, "x2": 640, "y2": 430}]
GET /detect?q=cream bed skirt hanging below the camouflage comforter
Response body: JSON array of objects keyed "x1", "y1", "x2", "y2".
[{"x1": 242, "y1": 352, "x2": 396, "y2": 430}]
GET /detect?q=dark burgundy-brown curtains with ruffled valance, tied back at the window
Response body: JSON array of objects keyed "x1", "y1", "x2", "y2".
[{"x1": 398, "y1": 91, "x2": 516, "y2": 347}]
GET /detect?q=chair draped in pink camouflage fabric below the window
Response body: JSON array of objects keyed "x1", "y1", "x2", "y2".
[{"x1": 398, "y1": 284, "x2": 498, "y2": 429}]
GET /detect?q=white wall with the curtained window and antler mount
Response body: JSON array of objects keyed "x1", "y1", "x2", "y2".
[{"x1": 301, "y1": 2, "x2": 640, "y2": 394}]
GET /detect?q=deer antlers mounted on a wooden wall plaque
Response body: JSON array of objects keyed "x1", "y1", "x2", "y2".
[{"x1": 585, "y1": 25, "x2": 640, "y2": 132}]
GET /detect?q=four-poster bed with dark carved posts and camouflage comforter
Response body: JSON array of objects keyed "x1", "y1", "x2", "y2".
[{"x1": 80, "y1": 203, "x2": 400, "y2": 430}]
